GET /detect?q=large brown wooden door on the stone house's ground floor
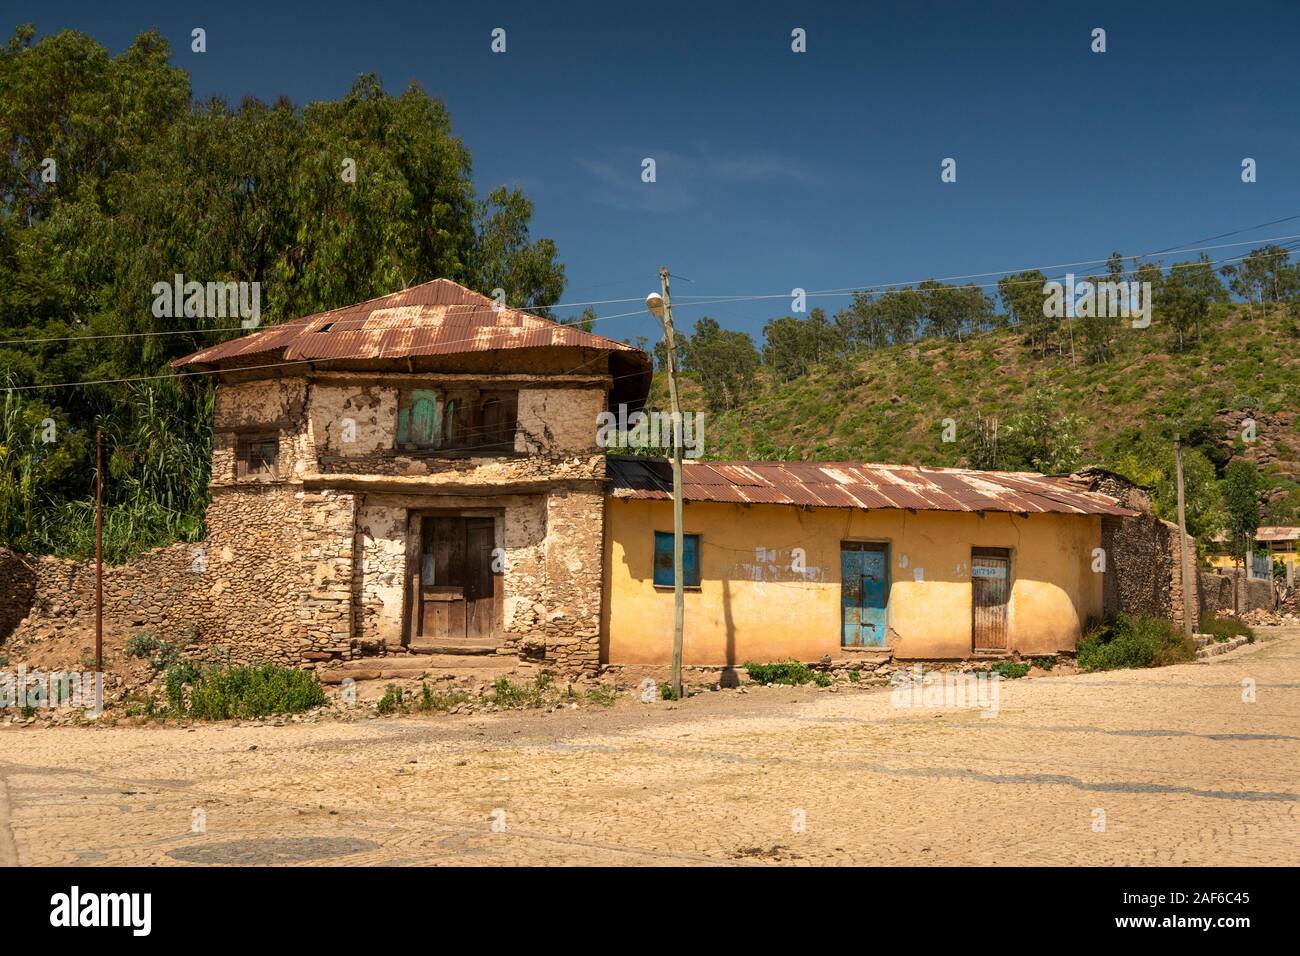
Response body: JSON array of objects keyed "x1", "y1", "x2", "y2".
[{"x1": 416, "y1": 516, "x2": 501, "y2": 640}]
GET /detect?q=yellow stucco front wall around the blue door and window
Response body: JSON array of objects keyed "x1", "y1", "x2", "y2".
[{"x1": 602, "y1": 497, "x2": 1102, "y2": 665}]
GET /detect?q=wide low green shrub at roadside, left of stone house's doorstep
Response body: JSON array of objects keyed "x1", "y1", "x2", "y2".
[{"x1": 168, "y1": 663, "x2": 325, "y2": 721}]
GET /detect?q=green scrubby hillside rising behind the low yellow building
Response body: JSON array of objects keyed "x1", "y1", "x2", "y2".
[{"x1": 651, "y1": 302, "x2": 1300, "y2": 533}]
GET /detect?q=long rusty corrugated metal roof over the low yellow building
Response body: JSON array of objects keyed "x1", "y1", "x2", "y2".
[{"x1": 607, "y1": 455, "x2": 1138, "y2": 516}]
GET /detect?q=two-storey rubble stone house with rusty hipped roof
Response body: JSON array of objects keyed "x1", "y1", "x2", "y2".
[{"x1": 176, "y1": 280, "x2": 650, "y2": 670}]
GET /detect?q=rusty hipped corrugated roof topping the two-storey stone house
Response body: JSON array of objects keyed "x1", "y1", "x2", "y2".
[{"x1": 173, "y1": 278, "x2": 638, "y2": 365}]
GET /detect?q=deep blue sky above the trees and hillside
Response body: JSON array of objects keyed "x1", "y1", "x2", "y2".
[{"x1": 10, "y1": 0, "x2": 1300, "y2": 338}]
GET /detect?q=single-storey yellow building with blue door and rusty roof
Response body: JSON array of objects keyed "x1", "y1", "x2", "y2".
[{"x1": 602, "y1": 463, "x2": 1132, "y2": 665}]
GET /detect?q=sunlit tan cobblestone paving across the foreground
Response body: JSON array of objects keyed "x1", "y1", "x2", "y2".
[{"x1": 0, "y1": 628, "x2": 1300, "y2": 865}]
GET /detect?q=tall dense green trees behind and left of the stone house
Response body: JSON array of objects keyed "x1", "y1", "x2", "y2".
[{"x1": 0, "y1": 26, "x2": 564, "y2": 554}]
